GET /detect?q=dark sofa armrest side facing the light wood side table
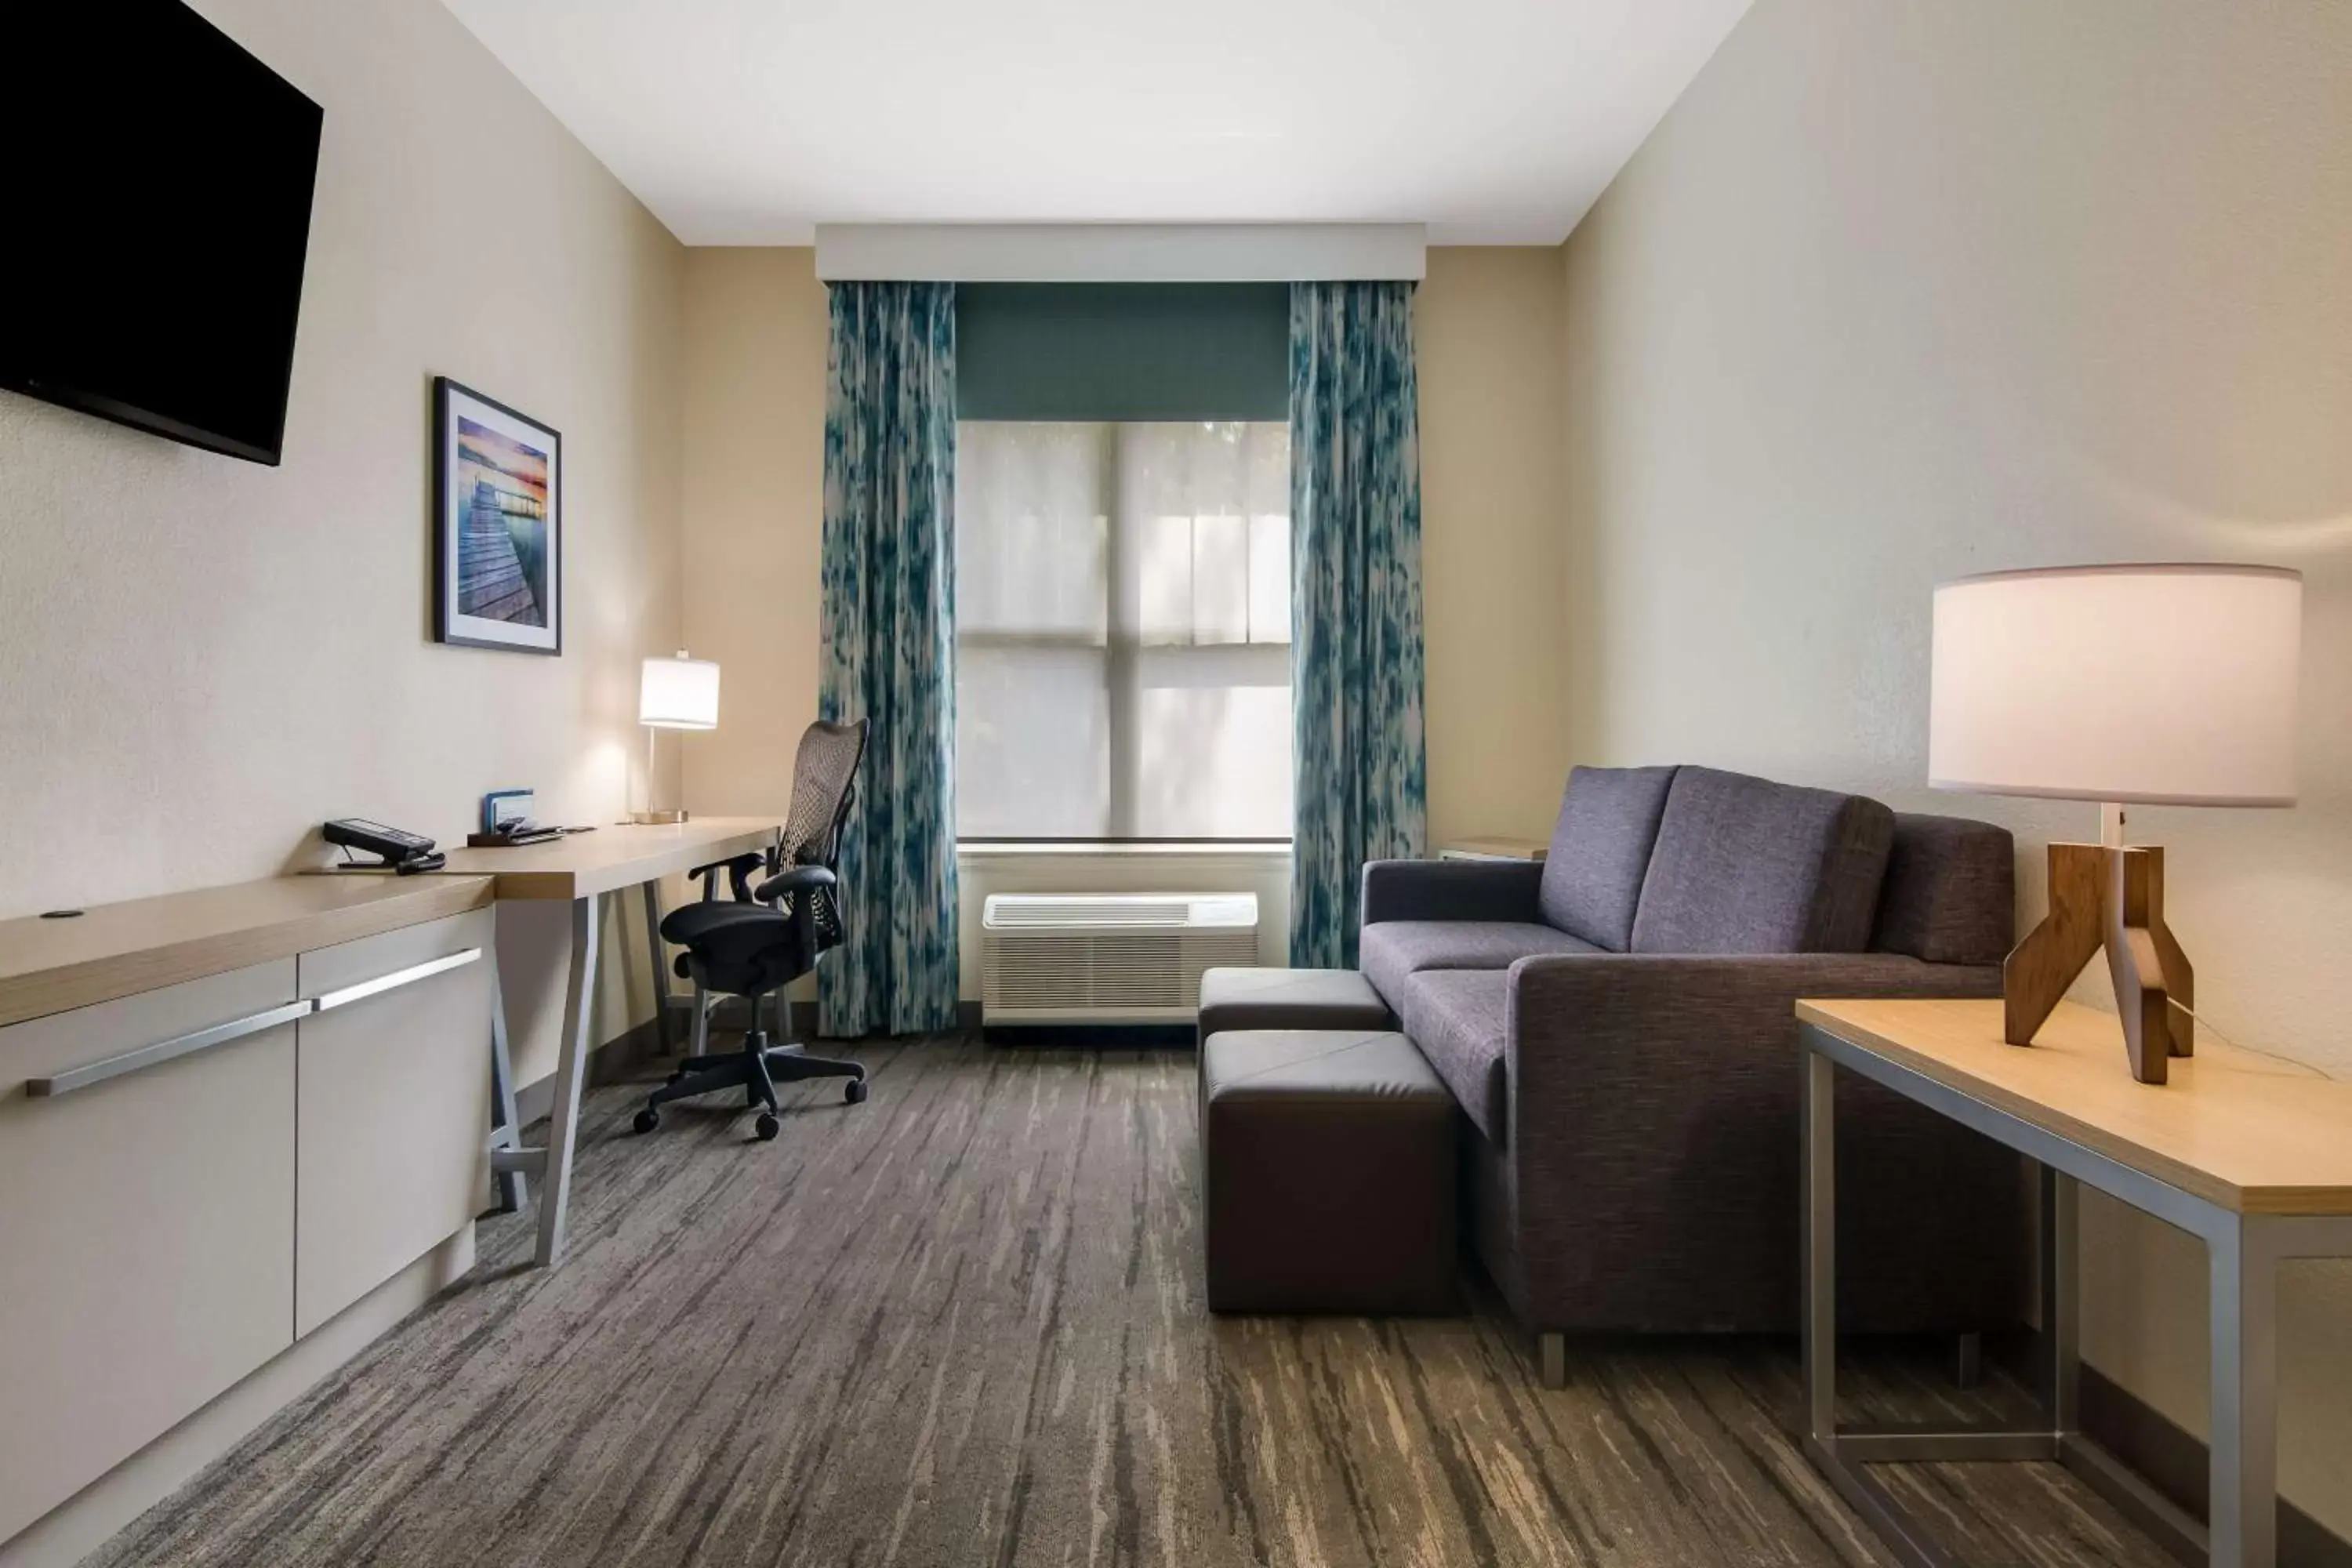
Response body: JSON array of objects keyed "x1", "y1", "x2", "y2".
[{"x1": 1501, "y1": 952, "x2": 2023, "y2": 1328}]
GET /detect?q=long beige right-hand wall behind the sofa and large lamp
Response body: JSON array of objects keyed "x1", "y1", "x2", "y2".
[{"x1": 1564, "y1": 0, "x2": 2352, "y2": 1535}]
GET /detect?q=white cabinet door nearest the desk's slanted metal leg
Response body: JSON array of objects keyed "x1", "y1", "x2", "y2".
[{"x1": 294, "y1": 909, "x2": 496, "y2": 1335}]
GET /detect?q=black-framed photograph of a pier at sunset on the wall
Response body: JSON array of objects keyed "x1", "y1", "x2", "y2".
[{"x1": 433, "y1": 376, "x2": 564, "y2": 654}]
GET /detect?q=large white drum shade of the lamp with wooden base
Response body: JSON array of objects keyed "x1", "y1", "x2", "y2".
[{"x1": 1926, "y1": 567, "x2": 2303, "y2": 806}]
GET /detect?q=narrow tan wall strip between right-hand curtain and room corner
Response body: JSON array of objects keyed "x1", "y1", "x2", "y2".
[{"x1": 1414, "y1": 247, "x2": 1569, "y2": 846}]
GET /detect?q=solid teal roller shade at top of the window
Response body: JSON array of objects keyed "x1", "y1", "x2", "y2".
[{"x1": 955, "y1": 282, "x2": 1291, "y2": 421}]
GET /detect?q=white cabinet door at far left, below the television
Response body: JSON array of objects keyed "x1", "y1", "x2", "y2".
[{"x1": 0, "y1": 959, "x2": 294, "y2": 1540}]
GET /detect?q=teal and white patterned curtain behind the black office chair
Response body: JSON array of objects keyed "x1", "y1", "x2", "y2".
[{"x1": 816, "y1": 282, "x2": 955, "y2": 1036}]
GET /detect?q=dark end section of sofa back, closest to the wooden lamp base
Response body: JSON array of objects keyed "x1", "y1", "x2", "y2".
[{"x1": 1870, "y1": 811, "x2": 2018, "y2": 964}]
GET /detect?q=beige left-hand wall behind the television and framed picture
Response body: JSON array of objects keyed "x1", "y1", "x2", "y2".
[{"x1": 0, "y1": 0, "x2": 684, "y2": 1076}]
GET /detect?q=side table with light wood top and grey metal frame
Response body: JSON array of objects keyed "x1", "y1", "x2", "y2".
[{"x1": 1797, "y1": 1001, "x2": 2352, "y2": 1568}]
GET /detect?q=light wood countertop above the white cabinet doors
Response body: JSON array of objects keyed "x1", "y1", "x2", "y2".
[{"x1": 0, "y1": 877, "x2": 494, "y2": 1025}]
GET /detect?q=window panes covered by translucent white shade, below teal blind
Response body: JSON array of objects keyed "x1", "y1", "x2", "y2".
[{"x1": 955, "y1": 419, "x2": 1291, "y2": 839}]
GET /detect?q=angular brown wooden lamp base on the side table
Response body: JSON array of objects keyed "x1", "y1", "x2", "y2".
[{"x1": 2002, "y1": 844, "x2": 2197, "y2": 1083}]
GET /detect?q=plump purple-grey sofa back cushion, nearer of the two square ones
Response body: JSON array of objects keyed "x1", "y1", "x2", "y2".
[{"x1": 1632, "y1": 767, "x2": 1896, "y2": 952}]
